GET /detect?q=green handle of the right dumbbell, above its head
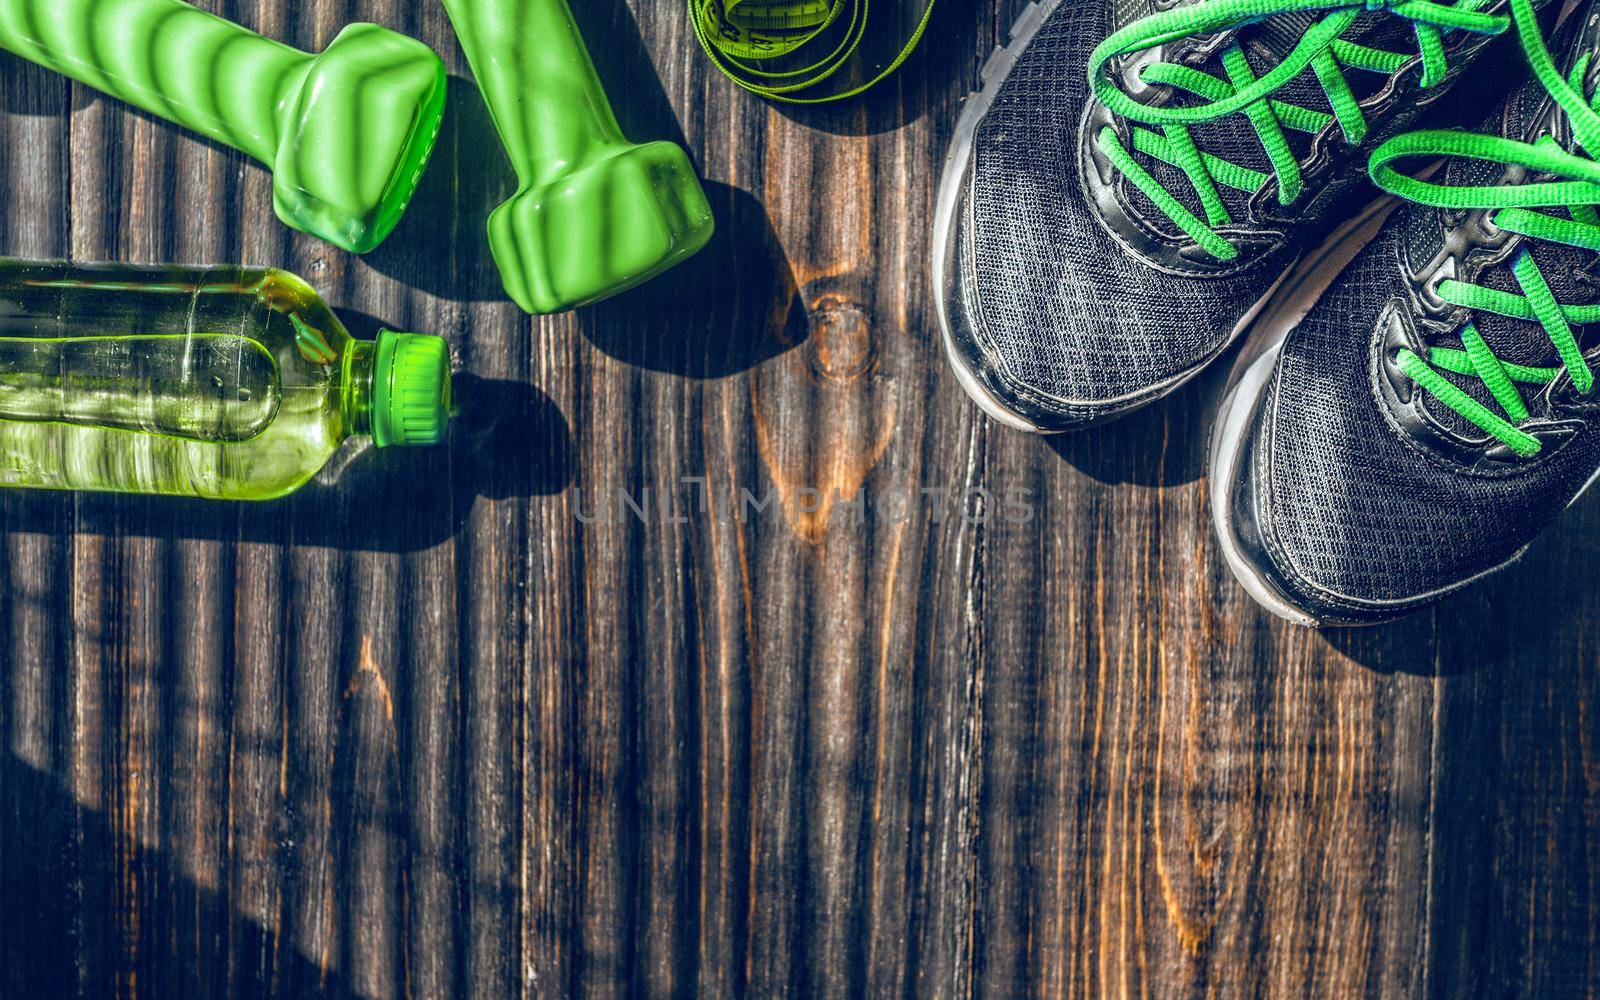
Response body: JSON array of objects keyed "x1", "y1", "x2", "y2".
[{"x1": 445, "y1": 0, "x2": 629, "y2": 189}]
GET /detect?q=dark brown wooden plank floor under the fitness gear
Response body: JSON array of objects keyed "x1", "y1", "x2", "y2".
[{"x1": 0, "y1": 0, "x2": 1600, "y2": 998}]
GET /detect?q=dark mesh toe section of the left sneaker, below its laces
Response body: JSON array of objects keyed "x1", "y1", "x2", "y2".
[{"x1": 970, "y1": 0, "x2": 1282, "y2": 400}]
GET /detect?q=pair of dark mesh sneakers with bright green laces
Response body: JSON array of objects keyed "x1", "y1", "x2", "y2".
[{"x1": 933, "y1": 0, "x2": 1600, "y2": 624}]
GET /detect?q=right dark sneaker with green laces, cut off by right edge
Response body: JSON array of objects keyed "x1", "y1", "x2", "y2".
[{"x1": 1211, "y1": 0, "x2": 1600, "y2": 624}]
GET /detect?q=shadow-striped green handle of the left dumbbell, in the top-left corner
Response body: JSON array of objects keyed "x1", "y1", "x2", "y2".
[{"x1": 0, "y1": 0, "x2": 312, "y2": 166}]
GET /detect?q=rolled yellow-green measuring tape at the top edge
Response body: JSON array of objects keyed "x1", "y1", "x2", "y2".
[{"x1": 688, "y1": 0, "x2": 934, "y2": 104}]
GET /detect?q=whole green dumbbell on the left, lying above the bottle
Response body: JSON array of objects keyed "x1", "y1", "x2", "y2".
[{"x1": 0, "y1": 0, "x2": 445, "y2": 253}]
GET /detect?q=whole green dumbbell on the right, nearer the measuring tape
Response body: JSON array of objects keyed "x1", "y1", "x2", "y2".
[{"x1": 445, "y1": 0, "x2": 714, "y2": 314}]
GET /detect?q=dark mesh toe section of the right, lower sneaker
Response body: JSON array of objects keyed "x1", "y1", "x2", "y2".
[{"x1": 1256, "y1": 220, "x2": 1600, "y2": 600}]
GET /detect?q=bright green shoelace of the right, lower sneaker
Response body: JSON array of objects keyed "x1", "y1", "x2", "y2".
[{"x1": 1371, "y1": 0, "x2": 1600, "y2": 458}]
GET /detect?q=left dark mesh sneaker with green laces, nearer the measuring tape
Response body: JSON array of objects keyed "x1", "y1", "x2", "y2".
[{"x1": 933, "y1": 0, "x2": 1529, "y2": 430}]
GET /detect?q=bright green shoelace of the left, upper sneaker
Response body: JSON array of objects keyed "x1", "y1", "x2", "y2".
[{"x1": 1090, "y1": 0, "x2": 1510, "y2": 261}]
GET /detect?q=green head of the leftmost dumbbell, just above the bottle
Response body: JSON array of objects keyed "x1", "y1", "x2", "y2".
[{"x1": 272, "y1": 24, "x2": 446, "y2": 253}]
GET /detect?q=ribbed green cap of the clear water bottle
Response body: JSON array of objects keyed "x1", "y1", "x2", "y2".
[{"x1": 373, "y1": 330, "x2": 450, "y2": 448}]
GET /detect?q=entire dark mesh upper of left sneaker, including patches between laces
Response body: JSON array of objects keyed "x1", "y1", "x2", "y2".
[{"x1": 958, "y1": 0, "x2": 1529, "y2": 402}]
